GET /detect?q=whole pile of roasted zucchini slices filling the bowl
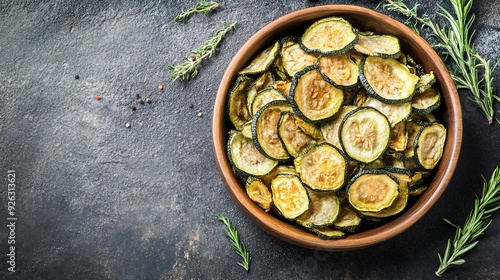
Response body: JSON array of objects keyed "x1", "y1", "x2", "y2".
[{"x1": 227, "y1": 17, "x2": 446, "y2": 239}]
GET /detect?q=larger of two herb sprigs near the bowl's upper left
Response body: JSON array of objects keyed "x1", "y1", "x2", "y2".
[{"x1": 167, "y1": 22, "x2": 237, "y2": 81}]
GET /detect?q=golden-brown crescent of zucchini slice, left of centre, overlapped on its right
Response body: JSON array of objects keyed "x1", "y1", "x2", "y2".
[{"x1": 252, "y1": 100, "x2": 292, "y2": 160}]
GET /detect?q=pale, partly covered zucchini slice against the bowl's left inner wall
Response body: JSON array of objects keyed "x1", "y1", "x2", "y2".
[{"x1": 227, "y1": 130, "x2": 278, "y2": 176}]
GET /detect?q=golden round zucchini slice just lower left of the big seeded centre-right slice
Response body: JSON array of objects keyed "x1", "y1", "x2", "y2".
[{"x1": 294, "y1": 142, "x2": 348, "y2": 191}]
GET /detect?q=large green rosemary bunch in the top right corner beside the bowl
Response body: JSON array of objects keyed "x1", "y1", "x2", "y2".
[{"x1": 383, "y1": 0, "x2": 500, "y2": 124}]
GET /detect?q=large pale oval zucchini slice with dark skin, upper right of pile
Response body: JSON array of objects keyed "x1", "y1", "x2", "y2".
[{"x1": 359, "y1": 56, "x2": 419, "y2": 103}]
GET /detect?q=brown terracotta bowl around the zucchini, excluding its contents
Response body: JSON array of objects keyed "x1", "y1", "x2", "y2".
[{"x1": 212, "y1": 5, "x2": 462, "y2": 251}]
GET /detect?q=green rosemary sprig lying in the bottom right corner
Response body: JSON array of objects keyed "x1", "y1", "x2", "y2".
[{"x1": 436, "y1": 166, "x2": 500, "y2": 277}]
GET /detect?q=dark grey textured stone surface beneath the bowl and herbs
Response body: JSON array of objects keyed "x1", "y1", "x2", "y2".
[{"x1": 0, "y1": 0, "x2": 500, "y2": 279}]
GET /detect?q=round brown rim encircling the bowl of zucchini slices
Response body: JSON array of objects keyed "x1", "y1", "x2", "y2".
[{"x1": 212, "y1": 5, "x2": 462, "y2": 251}]
